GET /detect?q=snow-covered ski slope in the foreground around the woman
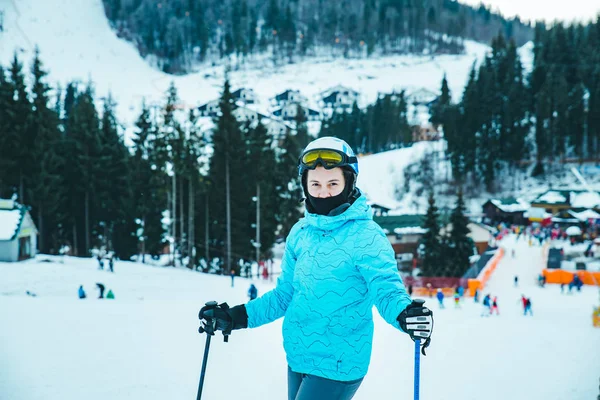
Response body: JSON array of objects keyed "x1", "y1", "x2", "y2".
[{"x1": 0, "y1": 237, "x2": 600, "y2": 400}]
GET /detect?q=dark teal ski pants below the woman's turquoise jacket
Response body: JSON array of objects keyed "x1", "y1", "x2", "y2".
[{"x1": 288, "y1": 367, "x2": 363, "y2": 400}]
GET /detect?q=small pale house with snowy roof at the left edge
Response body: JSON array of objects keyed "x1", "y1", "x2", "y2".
[{"x1": 0, "y1": 199, "x2": 38, "y2": 262}]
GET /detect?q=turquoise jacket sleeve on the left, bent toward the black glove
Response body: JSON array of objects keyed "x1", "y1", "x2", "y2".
[{"x1": 246, "y1": 224, "x2": 298, "y2": 328}]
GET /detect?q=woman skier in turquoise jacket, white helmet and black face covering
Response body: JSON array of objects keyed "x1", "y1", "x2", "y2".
[{"x1": 199, "y1": 137, "x2": 433, "y2": 400}]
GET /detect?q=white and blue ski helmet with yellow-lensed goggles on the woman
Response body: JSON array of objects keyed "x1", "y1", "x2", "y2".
[{"x1": 298, "y1": 136, "x2": 358, "y2": 176}]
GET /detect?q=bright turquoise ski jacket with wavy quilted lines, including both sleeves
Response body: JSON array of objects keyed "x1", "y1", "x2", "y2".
[{"x1": 246, "y1": 195, "x2": 411, "y2": 381}]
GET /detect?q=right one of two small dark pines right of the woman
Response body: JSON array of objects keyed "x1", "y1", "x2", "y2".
[{"x1": 446, "y1": 190, "x2": 473, "y2": 278}]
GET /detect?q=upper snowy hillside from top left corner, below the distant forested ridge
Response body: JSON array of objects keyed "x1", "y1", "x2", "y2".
[{"x1": 0, "y1": 0, "x2": 488, "y2": 138}]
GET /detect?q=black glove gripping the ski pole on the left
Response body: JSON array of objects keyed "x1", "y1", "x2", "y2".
[{"x1": 198, "y1": 301, "x2": 248, "y2": 337}]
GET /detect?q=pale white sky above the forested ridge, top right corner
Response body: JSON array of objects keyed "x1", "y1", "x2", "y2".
[{"x1": 460, "y1": 0, "x2": 600, "y2": 22}]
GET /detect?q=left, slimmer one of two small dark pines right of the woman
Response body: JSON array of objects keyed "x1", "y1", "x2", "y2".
[{"x1": 421, "y1": 192, "x2": 446, "y2": 276}]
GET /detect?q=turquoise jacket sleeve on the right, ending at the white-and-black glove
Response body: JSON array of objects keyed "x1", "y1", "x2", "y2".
[{"x1": 355, "y1": 222, "x2": 412, "y2": 329}]
